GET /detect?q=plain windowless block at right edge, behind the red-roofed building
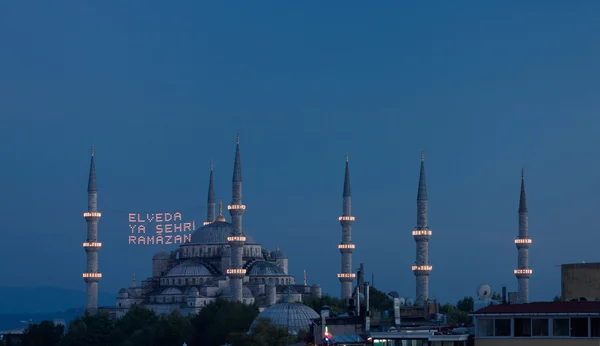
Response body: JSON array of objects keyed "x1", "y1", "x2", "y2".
[{"x1": 560, "y1": 262, "x2": 600, "y2": 302}]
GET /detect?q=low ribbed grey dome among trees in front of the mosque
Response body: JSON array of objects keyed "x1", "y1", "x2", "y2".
[{"x1": 250, "y1": 303, "x2": 319, "y2": 334}]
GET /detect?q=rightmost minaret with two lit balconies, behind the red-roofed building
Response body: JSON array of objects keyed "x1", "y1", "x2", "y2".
[{"x1": 515, "y1": 170, "x2": 533, "y2": 303}]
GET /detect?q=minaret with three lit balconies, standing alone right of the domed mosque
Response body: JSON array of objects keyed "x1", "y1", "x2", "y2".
[{"x1": 338, "y1": 153, "x2": 356, "y2": 299}]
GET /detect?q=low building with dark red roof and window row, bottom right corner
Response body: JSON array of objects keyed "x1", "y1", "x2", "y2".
[{"x1": 473, "y1": 302, "x2": 600, "y2": 346}]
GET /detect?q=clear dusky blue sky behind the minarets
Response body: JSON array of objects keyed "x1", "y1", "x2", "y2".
[{"x1": 0, "y1": 0, "x2": 600, "y2": 302}]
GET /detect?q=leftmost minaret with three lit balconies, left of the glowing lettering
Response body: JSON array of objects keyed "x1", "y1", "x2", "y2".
[{"x1": 83, "y1": 146, "x2": 102, "y2": 314}]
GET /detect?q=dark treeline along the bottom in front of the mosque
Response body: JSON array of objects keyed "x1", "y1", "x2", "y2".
[{"x1": 9, "y1": 301, "x2": 302, "y2": 346}]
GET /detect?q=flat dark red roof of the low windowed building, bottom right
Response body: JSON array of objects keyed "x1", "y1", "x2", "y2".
[{"x1": 473, "y1": 301, "x2": 600, "y2": 315}]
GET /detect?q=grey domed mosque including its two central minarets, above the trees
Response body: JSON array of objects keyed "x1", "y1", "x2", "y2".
[{"x1": 109, "y1": 137, "x2": 321, "y2": 317}]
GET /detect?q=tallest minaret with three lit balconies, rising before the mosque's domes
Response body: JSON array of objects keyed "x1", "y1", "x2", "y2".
[{"x1": 227, "y1": 133, "x2": 246, "y2": 302}]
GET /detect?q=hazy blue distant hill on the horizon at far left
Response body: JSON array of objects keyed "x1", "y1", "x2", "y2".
[{"x1": 0, "y1": 286, "x2": 116, "y2": 315}]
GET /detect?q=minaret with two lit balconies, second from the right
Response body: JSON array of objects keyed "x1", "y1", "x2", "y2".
[{"x1": 412, "y1": 152, "x2": 432, "y2": 306}]
